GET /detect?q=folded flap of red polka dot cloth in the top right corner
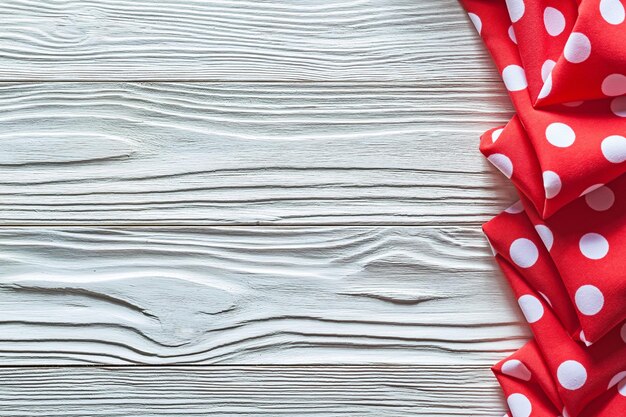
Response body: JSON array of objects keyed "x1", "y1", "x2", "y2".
[{"x1": 508, "y1": 0, "x2": 626, "y2": 106}]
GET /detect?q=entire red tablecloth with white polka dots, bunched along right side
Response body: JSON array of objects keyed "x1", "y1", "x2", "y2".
[{"x1": 454, "y1": 0, "x2": 626, "y2": 417}]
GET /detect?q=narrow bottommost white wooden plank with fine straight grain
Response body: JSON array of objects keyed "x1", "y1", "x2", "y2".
[{"x1": 0, "y1": 366, "x2": 505, "y2": 417}]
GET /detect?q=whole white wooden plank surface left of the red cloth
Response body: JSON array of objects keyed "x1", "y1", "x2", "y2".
[{"x1": 0, "y1": 0, "x2": 528, "y2": 417}]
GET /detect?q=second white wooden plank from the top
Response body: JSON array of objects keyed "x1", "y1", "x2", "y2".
[{"x1": 0, "y1": 81, "x2": 514, "y2": 225}]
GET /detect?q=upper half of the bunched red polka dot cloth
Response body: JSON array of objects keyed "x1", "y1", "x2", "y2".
[{"x1": 461, "y1": 0, "x2": 626, "y2": 218}]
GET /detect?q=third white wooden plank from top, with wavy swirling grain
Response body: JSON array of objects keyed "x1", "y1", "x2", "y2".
[{"x1": 0, "y1": 226, "x2": 528, "y2": 365}]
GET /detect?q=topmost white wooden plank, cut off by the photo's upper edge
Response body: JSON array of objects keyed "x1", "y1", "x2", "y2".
[{"x1": 0, "y1": 0, "x2": 491, "y2": 81}]
